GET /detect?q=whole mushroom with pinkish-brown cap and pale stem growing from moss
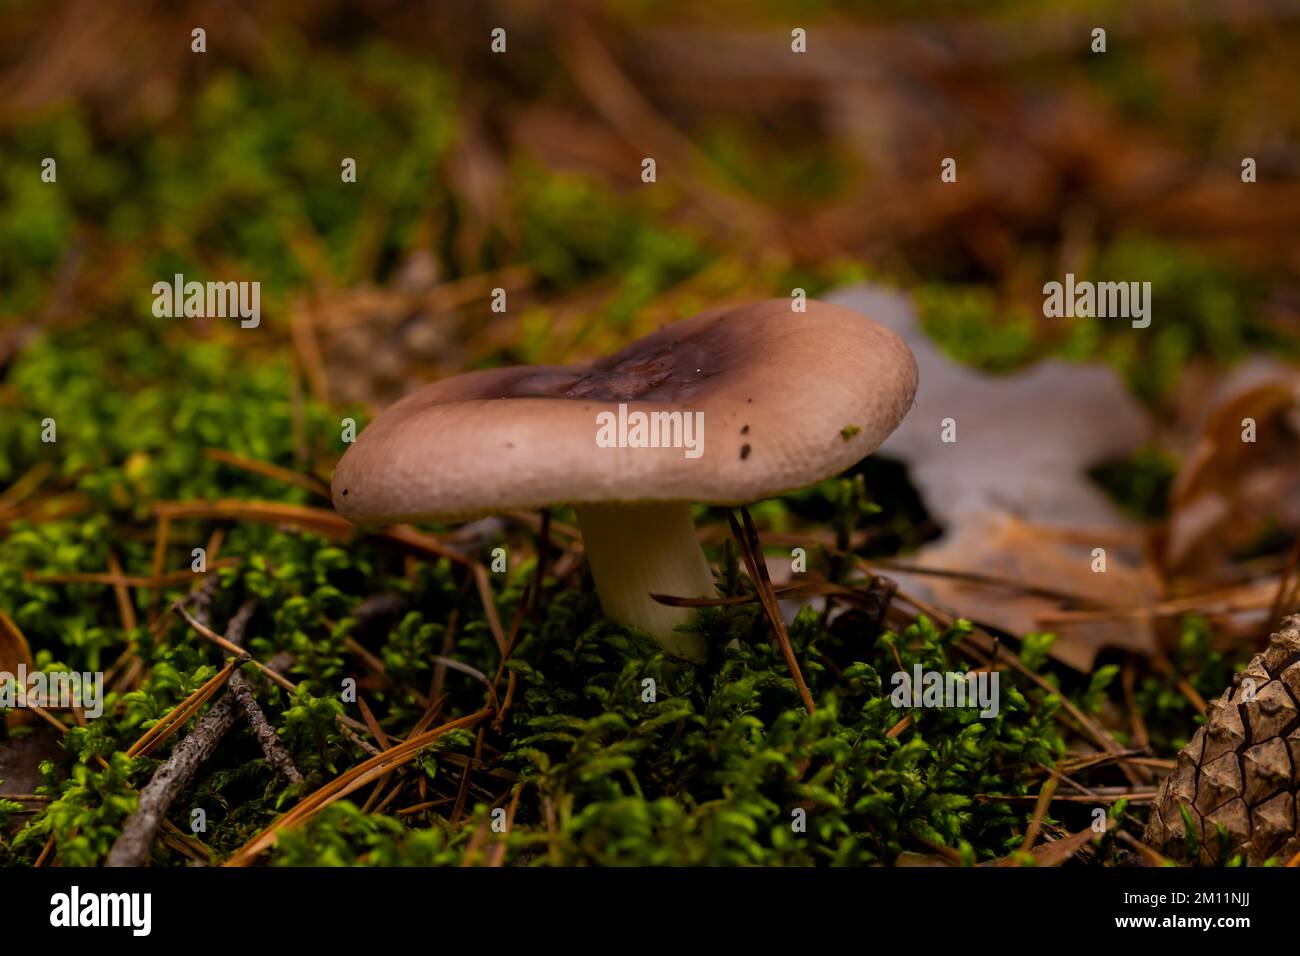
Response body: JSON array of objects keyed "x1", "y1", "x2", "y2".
[{"x1": 332, "y1": 299, "x2": 917, "y2": 661}]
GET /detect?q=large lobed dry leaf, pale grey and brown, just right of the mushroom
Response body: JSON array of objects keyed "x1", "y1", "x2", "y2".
[{"x1": 829, "y1": 286, "x2": 1161, "y2": 670}]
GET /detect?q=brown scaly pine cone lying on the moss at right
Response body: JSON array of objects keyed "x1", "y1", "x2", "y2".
[{"x1": 1147, "y1": 615, "x2": 1300, "y2": 866}]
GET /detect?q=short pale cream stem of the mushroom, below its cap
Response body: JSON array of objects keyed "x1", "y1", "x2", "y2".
[{"x1": 573, "y1": 502, "x2": 716, "y2": 661}]
